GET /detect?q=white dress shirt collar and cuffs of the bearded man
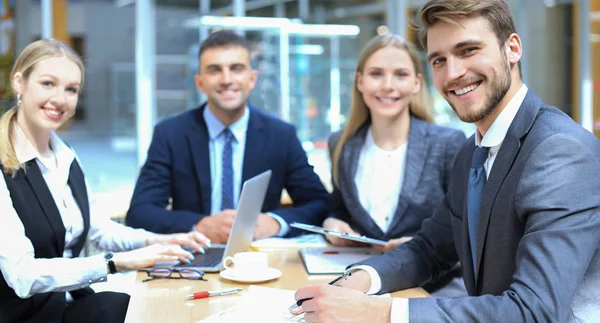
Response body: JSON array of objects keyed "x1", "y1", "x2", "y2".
[{"x1": 349, "y1": 84, "x2": 527, "y2": 323}]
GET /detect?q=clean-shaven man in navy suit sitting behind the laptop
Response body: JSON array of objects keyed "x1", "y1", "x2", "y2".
[{"x1": 126, "y1": 31, "x2": 328, "y2": 243}]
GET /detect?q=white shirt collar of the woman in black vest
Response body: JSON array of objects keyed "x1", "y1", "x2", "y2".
[{"x1": 14, "y1": 124, "x2": 75, "y2": 172}]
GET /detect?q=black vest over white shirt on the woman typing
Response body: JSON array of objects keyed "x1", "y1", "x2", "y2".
[{"x1": 0, "y1": 159, "x2": 93, "y2": 323}]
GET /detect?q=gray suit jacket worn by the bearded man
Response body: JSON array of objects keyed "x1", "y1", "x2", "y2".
[{"x1": 364, "y1": 91, "x2": 600, "y2": 323}]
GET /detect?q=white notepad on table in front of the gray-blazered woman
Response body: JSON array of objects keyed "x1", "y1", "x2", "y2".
[{"x1": 299, "y1": 247, "x2": 383, "y2": 275}]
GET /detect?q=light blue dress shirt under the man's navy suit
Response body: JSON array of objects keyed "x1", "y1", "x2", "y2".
[{"x1": 203, "y1": 106, "x2": 290, "y2": 237}]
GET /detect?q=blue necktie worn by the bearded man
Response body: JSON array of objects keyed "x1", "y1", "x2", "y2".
[{"x1": 467, "y1": 147, "x2": 490, "y2": 276}]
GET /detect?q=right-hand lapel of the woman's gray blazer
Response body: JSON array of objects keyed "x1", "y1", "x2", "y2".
[{"x1": 388, "y1": 115, "x2": 430, "y2": 233}]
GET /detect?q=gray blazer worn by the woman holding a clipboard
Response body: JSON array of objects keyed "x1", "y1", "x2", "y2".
[{"x1": 329, "y1": 115, "x2": 466, "y2": 240}]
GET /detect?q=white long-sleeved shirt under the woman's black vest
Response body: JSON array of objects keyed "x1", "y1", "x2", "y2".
[{"x1": 0, "y1": 126, "x2": 151, "y2": 300}]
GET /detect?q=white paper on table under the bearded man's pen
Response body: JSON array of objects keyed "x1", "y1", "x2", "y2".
[{"x1": 197, "y1": 285, "x2": 306, "y2": 323}]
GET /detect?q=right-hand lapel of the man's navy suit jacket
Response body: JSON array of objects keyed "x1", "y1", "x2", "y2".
[{"x1": 240, "y1": 107, "x2": 267, "y2": 186}]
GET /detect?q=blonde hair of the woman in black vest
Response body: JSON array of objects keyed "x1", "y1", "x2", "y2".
[{"x1": 0, "y1": 38, "x2": 84, "y2": 176}]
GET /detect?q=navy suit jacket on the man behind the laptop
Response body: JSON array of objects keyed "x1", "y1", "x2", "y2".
[{"x1": 126, "y1": 104, "x2": 328, "y2": 236}]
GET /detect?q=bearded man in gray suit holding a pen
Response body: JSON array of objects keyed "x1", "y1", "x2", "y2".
[{"x1": 292, "y1": 0, "x2": 600, "y2": 323}]
